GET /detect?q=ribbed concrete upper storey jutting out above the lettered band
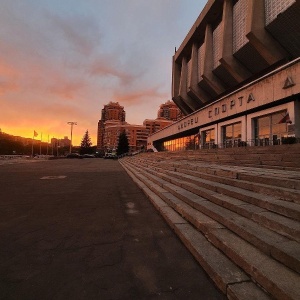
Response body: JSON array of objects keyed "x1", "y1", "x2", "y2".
[{"x1": 172, "y1": 0, "x2": 300, "y2": 115}]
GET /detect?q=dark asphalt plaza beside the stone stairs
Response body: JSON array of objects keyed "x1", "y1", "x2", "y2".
[{"x1": 0, "y1": 159, "x2": 224, "y2": 300}]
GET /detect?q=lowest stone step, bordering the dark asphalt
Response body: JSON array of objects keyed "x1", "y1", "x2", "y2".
[{"x1": 122, "y1": 162, "x2": 271, "y2": 300}]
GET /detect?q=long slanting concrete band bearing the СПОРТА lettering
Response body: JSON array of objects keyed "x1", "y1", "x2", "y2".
[{"x1": 148, "y1": 58, "x2": 300, "y2": 144}]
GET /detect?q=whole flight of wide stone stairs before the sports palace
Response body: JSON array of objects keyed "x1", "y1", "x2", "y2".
[{"x1": 119, "y1": 145, "x2": 300, "y2": 300}]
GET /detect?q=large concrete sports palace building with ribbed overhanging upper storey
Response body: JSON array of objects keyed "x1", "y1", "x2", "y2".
[{"x1": 148, "y1": 0, "x2": 300, "y2": 150}]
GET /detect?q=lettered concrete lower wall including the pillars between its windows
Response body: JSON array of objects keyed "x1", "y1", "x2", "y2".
[{"x1": 148, "y1": 58, "x2": 300, "y2": 148}]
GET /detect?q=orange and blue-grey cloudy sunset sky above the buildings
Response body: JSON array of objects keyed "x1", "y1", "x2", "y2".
[{"x1": 0, "y1": 0, "x2": 206, "y2": 145}]
